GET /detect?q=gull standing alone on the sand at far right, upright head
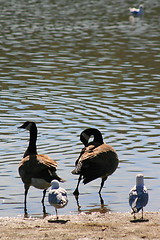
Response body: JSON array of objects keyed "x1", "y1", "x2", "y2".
[{"x1": 129, "y1": 174, "x2": 148, "y2": 220}]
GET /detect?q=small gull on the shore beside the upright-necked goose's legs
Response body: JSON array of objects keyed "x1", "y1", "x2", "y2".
[{"x1": 48, "y1": 180, "x2": 68, "y2": 219}]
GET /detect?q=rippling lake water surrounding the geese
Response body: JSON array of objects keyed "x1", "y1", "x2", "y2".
[{"x1": 0, "y1": 0, "x2": 160, "y2": 216}]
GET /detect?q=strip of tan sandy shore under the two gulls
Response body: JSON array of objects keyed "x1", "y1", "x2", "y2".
[{"x1": 0, "y1": 212, "x2": 160, "y2": 240}]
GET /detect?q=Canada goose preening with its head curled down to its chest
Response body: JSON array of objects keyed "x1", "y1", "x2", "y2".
[{"x1": 72, "y1": 128, "x2": 118, "y2": 200}]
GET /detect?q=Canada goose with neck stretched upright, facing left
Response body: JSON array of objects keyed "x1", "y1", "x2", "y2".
[{"x1": 18, "y1": 121, "x2": 63, "y2": 215}]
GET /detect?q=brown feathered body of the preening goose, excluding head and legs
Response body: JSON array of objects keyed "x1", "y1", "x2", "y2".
[{"x1": 72, "y1": 144, "x2": 118, "y2": 184}]
